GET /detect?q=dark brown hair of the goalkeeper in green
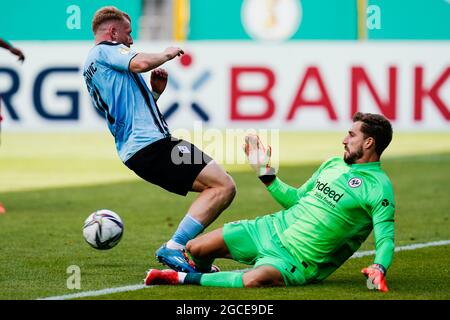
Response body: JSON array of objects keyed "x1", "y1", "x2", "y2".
[{"x1": 353, "y1": 112, "x2": 392, "y2": 156}]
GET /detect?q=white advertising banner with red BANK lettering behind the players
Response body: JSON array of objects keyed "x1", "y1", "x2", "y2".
[{"x1": 0, "y1": 41, "x2": 450, "y2": 131}]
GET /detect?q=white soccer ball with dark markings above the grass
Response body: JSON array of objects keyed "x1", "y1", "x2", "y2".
[{"x1": 83, "y1": 209, "x2": 123, "y2": 250}]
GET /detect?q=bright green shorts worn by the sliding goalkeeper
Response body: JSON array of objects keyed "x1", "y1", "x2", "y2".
[{"x1": 223, "y1": 215, "x2": 306, "y2": 286}]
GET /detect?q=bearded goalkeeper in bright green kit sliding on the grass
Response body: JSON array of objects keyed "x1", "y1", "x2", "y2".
[{"x1": 145, "y1": 112, "x2": 395, "y2": 292}]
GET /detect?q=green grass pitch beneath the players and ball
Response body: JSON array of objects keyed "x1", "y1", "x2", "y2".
[{"x1": 0, "y1": 133, "x2": 450, "y2": 300}]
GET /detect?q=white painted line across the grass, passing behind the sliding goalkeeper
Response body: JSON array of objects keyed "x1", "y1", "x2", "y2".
[{"x1": 37, "y1": 240, "x2": 450, "y2": 300}]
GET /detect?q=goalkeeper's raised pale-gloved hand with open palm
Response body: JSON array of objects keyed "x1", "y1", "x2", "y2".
[{"x1": 244, "y1": 134, "x2": 275, "y2": 177}]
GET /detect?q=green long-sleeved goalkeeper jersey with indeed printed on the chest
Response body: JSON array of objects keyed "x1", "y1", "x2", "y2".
[{"x1": 268, "y1": 157, "x2": 395, "y2": 280}]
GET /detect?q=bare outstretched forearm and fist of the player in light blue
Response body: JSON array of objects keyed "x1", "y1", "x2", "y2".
[{"x1": 129, "y1": 47, "x2": 184, "y2": 73}]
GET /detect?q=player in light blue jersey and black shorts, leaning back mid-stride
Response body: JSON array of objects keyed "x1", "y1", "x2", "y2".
[{"x1": 83, "y1": 7, "x2": 236, "y2": 272}]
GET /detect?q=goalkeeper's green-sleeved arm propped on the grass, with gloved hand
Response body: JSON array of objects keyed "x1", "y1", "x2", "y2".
[{"x1": 361, "y1": 188, "x2": 395, "y2": 292}]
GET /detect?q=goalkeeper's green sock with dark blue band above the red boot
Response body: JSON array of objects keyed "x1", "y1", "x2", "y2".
[{"x1": 183, "y1": 271, "x2": 244, "y2": 288}]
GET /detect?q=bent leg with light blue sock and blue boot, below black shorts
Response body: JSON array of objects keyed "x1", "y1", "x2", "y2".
[{"x1": 156, "y1": 161, "x2": 236, "y2": 273}]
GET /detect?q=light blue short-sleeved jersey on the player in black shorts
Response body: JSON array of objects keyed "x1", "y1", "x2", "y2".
[{"x1": 83, "y1": 41, "x2": 170, "y2": 162}]
